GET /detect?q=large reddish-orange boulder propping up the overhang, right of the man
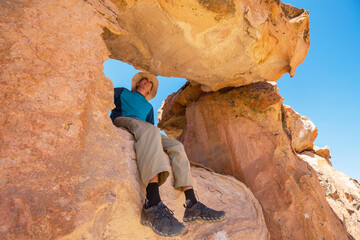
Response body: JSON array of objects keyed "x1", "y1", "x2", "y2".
[{"x1": 160, "y1": 83, "x2": 347, "y2": 239}]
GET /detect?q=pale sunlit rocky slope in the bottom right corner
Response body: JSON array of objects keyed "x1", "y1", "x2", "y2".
[{"x1": 298, "y1": 151, "x2": 360, "y2": 239}]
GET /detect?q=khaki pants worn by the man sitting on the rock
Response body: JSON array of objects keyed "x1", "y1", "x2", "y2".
[{"x1": 114, "y1": 117, "x2": 193, "y2": 189}]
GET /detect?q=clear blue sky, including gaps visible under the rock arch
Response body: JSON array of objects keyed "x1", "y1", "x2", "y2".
[{"x1": 104, "y1": 0, "x2": 360, "y2": 181}]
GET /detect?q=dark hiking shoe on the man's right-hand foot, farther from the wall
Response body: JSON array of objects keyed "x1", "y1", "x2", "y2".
[{"x1": 183, "y1": 201, "x2": 225, "y2": 222}]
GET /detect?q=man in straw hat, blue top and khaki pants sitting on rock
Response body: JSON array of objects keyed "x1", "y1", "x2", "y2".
[{"x1": 110, "y1": 72, "x2": 225, "y2": 236}]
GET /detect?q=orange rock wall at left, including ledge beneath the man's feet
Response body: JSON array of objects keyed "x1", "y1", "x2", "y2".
[{"x1": 0, "y1": 0, "x2": 269, "y2": 240}]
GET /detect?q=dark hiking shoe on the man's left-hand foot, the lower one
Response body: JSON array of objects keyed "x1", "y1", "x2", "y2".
[{"x1": 141, "y1": 201, "x2": 187, "y2": 237}]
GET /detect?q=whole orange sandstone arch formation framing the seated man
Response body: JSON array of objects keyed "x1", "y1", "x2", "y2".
[{"x1": 0, "y1": 0, "x2": 352, "y2": 239}]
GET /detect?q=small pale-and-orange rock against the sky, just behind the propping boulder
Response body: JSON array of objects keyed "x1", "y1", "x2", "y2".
[{"x1": 283, "y1": 105, "x2": 317, "y2": 153}]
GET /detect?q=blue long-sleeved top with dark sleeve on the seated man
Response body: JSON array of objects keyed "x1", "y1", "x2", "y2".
[{"x1": 110, "y1": 88, "x2": 154, "y2": 124}]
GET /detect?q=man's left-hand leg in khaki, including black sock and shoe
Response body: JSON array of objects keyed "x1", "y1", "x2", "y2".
[{"x1": 114, "y1": 117, "x2": 187, "y2": 236}]
